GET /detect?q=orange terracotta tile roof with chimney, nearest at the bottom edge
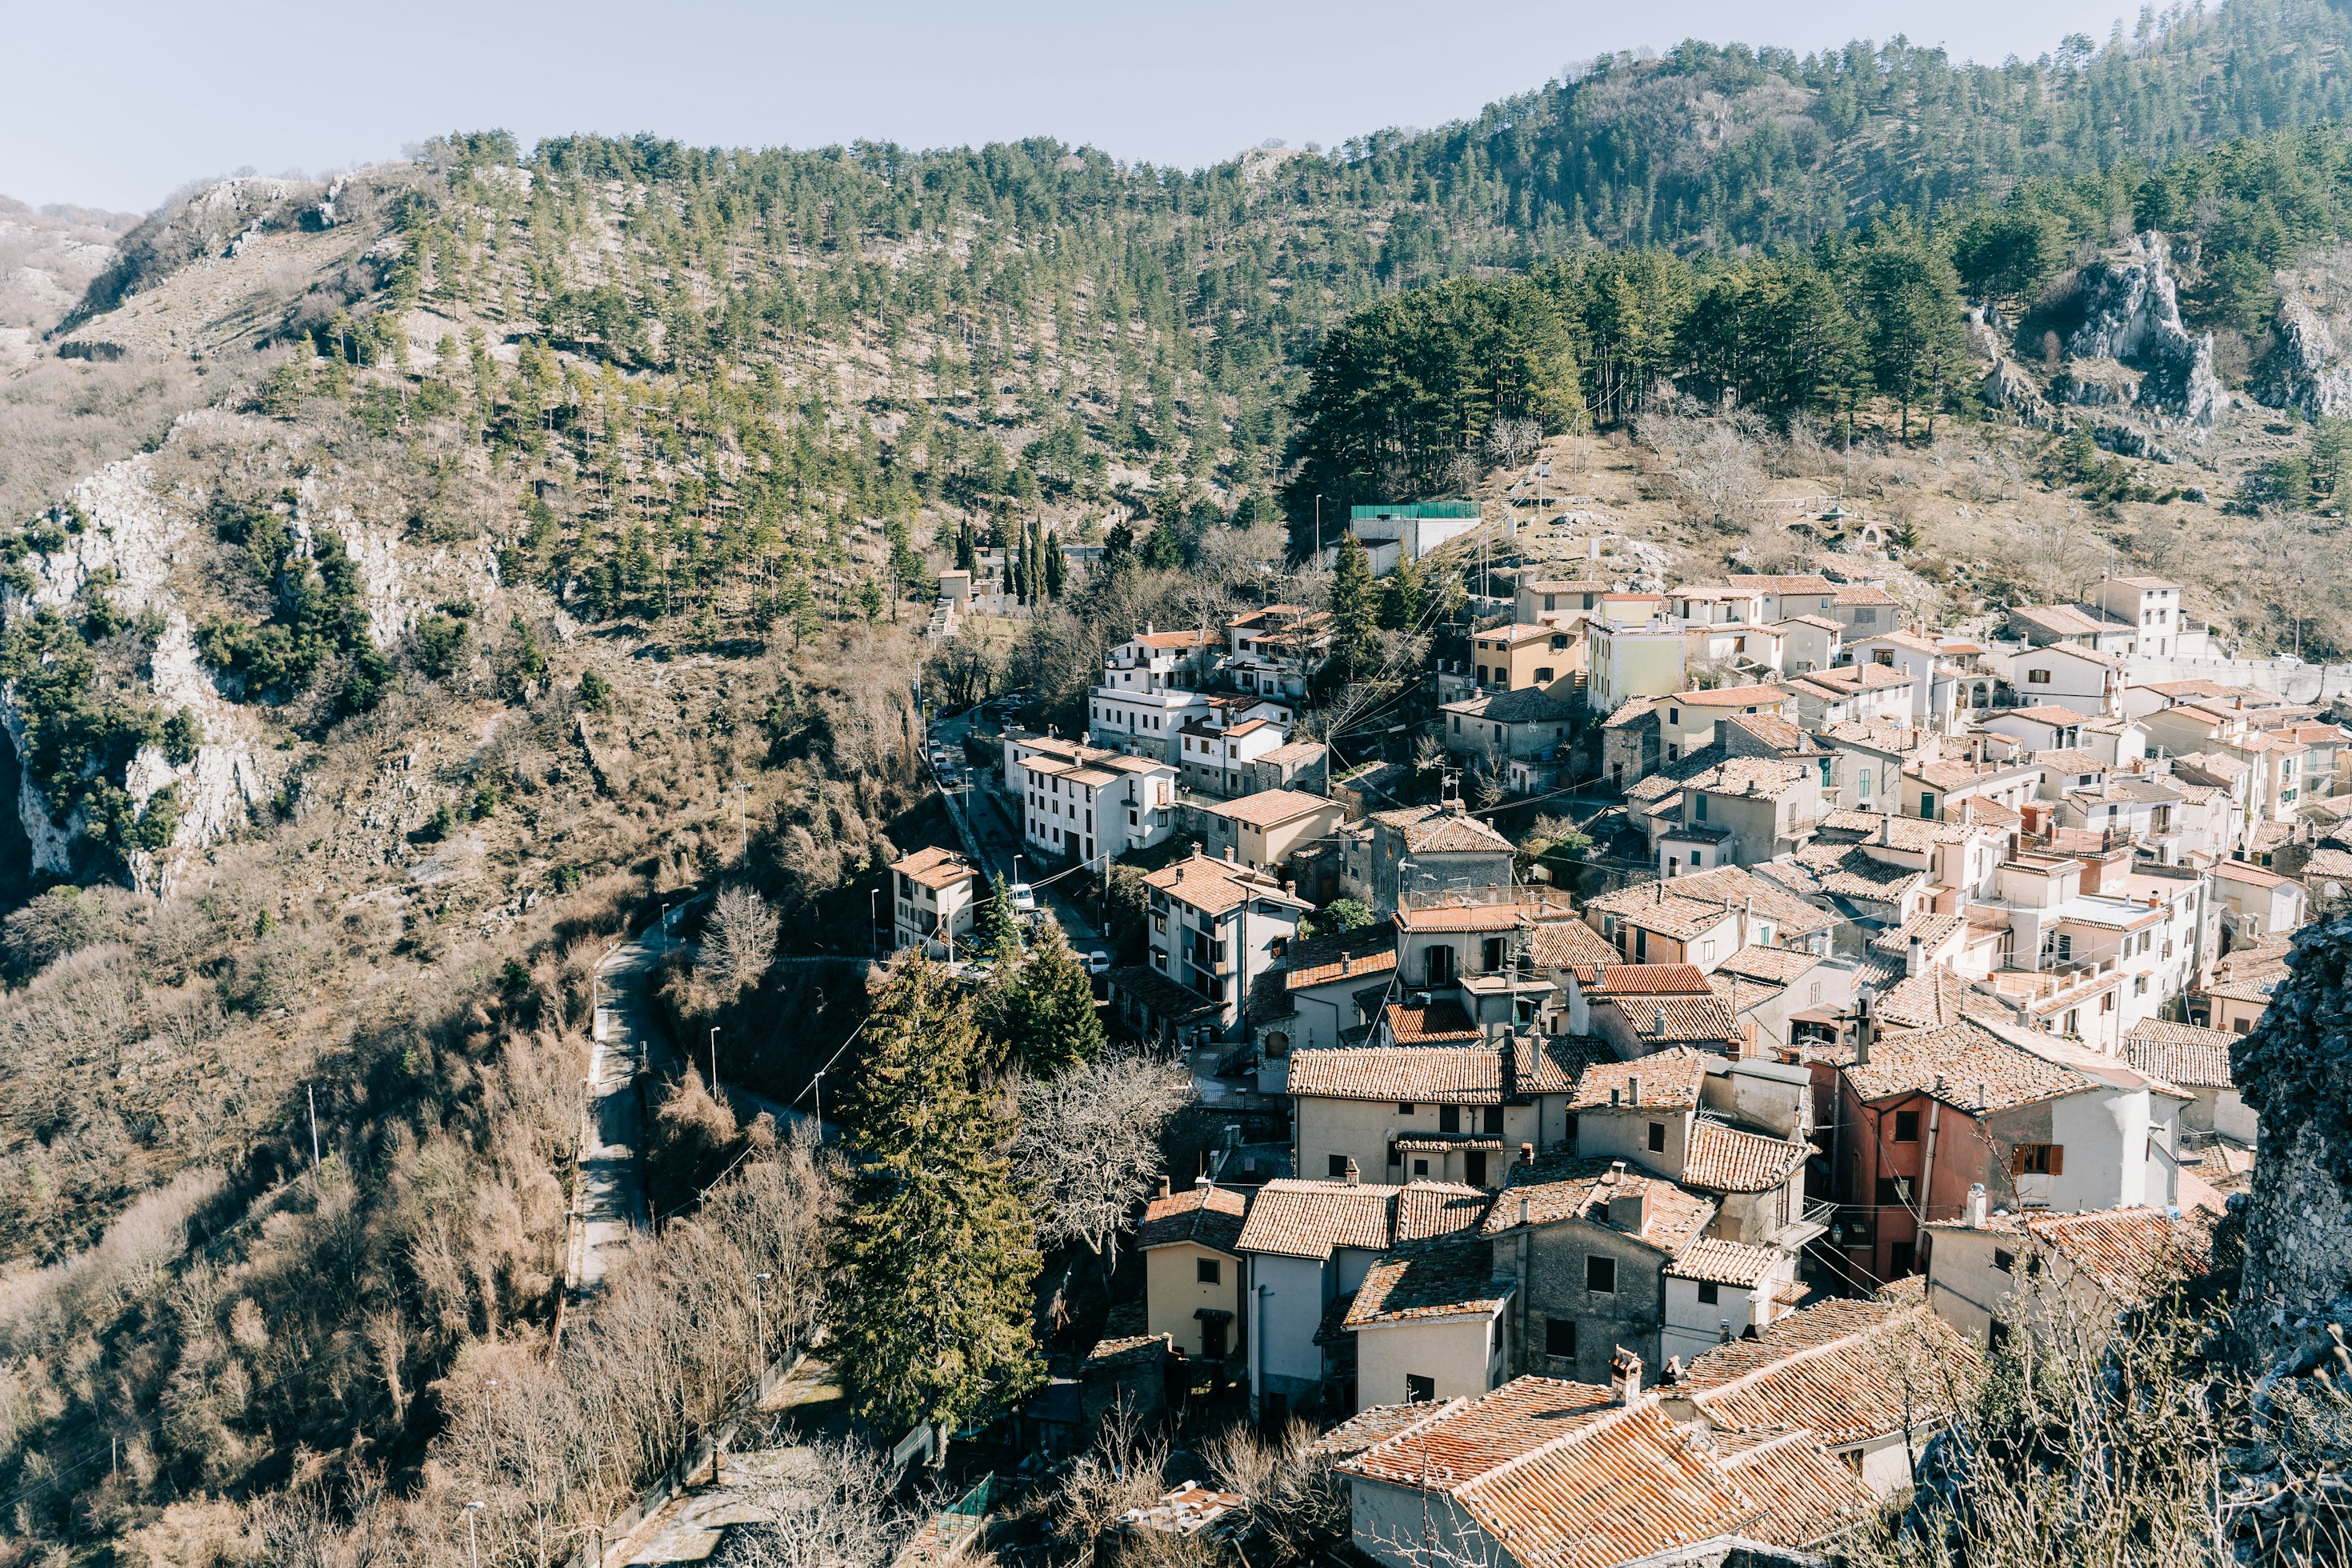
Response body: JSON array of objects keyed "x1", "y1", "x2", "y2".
[{"x1": 1346, "y1": 1378, "x2": 1757, "y2": 1568}]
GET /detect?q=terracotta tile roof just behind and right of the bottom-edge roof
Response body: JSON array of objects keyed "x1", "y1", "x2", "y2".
[{"x1": 1674, "y1": 1279, "x2": 1978, "y2": 1446}]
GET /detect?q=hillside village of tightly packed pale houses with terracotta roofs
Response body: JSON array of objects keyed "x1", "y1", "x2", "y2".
[{"x1": 891, "y1": 503, "x2": 2352, "y2": 1568}]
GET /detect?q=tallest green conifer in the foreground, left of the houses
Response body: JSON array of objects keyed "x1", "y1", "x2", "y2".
[{"x1": 830, "y1": 959, "x2": 1044, "y2": 1434}]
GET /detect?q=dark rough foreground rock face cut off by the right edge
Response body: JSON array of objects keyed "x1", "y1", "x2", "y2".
[{"x1": 2230, "y1": 919, "x2": 2352, "y2": 1370}]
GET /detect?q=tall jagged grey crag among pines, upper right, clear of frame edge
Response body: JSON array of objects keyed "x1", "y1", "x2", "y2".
[{"x1": 2065, "y1": 233, "x2": 2230, "y2": 428}]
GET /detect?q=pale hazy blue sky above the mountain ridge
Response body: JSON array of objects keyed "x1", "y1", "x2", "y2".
[{"x1": 0, "y1": 0, "x2": 2136, "y2": 210}]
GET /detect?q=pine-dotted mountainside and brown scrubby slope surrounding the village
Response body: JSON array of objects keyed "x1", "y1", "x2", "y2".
[{"x1": 0, "y1": 0, "x2": 2352, "y2": 1568}]
